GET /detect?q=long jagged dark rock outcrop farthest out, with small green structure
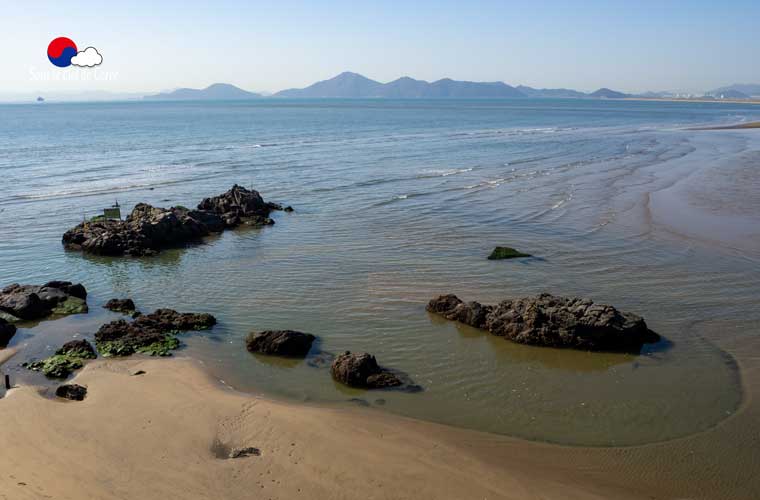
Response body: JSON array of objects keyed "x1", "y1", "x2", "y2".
[{"x1": 63, "y1": 185, "x2": 288, "y2": 256}]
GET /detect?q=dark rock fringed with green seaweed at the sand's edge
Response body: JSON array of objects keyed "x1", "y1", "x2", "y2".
[{"x1": 95, "y1": 309, "x2": 216, "y2": 356}]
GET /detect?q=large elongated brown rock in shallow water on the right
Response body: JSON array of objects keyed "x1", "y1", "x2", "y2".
[{"x1": 427, "y1": 294, "x2": 660, "y2": 353}]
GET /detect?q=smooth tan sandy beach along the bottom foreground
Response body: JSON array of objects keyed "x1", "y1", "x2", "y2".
[{"x1": 0, "y1": 348, "x2": 760, "y2": 500}]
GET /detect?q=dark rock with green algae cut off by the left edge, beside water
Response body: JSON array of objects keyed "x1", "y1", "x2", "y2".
[{"x1": 0, "y1": 281, "x2": 87, "y2": 320}]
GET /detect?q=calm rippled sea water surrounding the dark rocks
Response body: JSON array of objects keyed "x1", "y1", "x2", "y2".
[{"x1": 0, "y1": 100, "x2": 760, "y2": 445}]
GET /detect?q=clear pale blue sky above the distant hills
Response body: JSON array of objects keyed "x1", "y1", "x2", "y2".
[{"x1": 0, "y1": 0, "x2": 760, "y2": 94}]
